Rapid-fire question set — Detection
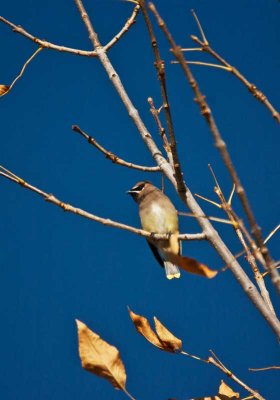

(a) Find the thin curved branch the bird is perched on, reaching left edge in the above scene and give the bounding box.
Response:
[0,165,206,240]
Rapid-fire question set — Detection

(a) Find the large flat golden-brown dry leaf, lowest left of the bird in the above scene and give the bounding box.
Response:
[76,320,126,390]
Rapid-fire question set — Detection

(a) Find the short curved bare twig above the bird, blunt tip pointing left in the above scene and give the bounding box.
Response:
[72,125,160,172]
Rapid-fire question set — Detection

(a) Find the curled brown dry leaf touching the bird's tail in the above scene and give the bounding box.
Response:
[168,254,218,279]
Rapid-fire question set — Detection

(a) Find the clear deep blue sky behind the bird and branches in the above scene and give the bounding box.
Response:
[0,0,280,400]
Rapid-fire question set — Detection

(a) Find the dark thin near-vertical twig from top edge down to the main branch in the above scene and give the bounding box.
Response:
[138,0,186,193]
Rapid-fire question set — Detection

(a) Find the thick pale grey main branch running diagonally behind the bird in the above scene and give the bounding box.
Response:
[70,0,280,338]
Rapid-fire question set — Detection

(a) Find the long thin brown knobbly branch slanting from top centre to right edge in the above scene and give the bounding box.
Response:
[150,3,280,294]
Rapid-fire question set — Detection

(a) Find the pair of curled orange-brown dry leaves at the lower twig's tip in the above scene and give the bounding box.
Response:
[128,309,182,353]
